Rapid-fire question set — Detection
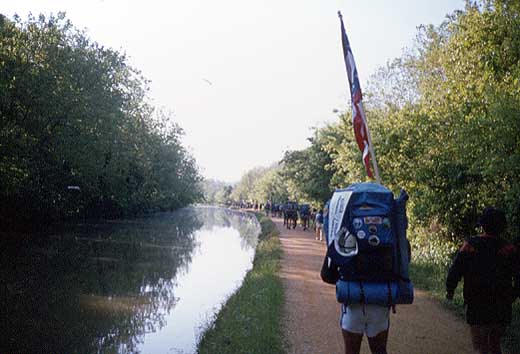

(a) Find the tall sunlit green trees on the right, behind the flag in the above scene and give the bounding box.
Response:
[323,1,520,239]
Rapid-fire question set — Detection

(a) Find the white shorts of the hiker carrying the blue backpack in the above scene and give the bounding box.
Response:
[340,304,390,338]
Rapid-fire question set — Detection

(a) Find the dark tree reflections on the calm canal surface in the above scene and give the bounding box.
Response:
[0,207,260,353]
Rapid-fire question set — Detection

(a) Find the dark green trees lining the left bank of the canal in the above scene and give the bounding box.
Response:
[0,14,201,227]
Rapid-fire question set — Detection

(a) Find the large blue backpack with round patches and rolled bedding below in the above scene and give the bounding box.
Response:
[323,183,413,306]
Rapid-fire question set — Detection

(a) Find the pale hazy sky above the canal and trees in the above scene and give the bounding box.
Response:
[6,0,464,181]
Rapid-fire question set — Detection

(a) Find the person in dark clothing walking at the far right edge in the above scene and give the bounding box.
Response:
[446,207,520,354]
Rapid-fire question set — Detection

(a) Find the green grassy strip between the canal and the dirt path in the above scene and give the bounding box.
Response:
[198,214,284,354]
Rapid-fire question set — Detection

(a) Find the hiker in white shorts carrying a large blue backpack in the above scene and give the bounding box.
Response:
[321,183,413,354]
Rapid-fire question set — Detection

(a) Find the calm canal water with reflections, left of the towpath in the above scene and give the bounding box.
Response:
[0,207,260,354]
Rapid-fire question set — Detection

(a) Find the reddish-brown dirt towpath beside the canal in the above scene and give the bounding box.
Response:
[273,218,472,354]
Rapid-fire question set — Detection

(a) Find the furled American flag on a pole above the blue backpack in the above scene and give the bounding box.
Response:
[338,11,374,178]
